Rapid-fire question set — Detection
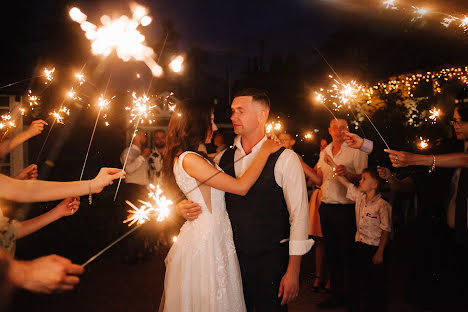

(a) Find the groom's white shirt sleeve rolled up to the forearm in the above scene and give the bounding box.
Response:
[275,150,314,256]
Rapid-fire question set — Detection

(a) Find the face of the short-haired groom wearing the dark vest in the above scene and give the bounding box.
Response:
[231,96,268,135]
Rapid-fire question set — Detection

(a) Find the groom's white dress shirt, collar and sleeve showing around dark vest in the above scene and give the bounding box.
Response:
[214,136,314,256]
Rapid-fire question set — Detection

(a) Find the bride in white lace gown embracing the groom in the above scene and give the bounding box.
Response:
[159,104,280,312]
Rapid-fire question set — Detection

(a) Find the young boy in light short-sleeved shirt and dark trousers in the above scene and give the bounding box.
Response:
[337,168,392,311]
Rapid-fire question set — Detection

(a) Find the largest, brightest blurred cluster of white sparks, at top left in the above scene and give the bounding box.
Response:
[69,3,163,77]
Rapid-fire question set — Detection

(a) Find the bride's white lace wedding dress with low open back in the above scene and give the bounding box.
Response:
[160,152,246,312]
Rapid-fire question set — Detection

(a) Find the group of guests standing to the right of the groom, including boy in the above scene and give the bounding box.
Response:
[279,103,468,311]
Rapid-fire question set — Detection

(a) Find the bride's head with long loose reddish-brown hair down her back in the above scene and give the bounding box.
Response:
[163,101,213,200]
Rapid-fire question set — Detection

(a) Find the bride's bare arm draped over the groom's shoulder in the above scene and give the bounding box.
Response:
[182,141,280,195]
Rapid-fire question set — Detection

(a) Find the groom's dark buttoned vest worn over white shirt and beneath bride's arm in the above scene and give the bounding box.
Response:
[219,147,289,253]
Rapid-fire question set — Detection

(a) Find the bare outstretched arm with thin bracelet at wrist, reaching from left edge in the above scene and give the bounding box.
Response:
[0,168,123,203]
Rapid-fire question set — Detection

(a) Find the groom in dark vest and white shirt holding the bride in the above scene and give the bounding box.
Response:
[179,89,313,312]
